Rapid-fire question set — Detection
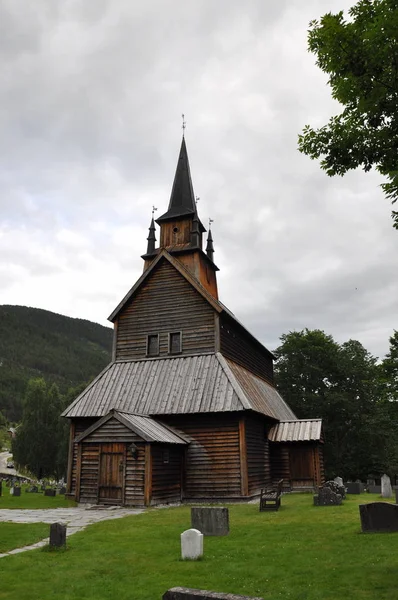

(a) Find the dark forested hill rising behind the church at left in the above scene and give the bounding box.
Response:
[0,305,112,421]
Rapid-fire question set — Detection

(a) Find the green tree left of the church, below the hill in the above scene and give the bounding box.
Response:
[12,379,63,478]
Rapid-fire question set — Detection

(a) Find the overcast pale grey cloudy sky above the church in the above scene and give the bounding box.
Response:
[0,0,398,357]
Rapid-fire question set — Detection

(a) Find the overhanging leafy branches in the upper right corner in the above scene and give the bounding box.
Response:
[299,0,398,229]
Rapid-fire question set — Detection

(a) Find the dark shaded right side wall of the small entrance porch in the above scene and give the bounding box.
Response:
[152,444,183,504]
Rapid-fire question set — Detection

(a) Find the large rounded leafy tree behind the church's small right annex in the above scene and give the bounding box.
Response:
[275,329,392,478]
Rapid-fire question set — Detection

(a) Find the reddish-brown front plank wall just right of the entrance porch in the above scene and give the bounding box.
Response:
[164,413,241,500]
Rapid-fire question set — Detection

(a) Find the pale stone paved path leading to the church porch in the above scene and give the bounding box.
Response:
[0,507,143,558]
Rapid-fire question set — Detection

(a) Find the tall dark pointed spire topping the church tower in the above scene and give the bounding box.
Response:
[156,137,199,227]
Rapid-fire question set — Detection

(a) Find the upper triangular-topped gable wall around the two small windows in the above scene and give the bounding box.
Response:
[116,261,214,360]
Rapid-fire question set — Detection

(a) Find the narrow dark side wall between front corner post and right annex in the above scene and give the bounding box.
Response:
[246,415,271,496]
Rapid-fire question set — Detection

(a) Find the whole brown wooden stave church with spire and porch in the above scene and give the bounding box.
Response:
[63,137,324,506]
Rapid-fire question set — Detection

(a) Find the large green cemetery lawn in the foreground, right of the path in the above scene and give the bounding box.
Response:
[0,494,398,600]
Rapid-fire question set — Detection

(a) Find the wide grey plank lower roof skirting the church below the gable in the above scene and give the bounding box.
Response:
[63,353,296,421]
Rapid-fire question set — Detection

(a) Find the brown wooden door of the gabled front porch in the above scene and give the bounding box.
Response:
[98,444,126,504]
